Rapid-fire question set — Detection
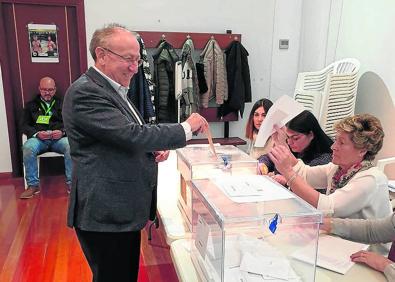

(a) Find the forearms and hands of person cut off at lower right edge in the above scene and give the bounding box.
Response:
[321,214,395,281]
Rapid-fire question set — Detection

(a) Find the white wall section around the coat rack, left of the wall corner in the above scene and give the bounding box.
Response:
[85,0,278,141]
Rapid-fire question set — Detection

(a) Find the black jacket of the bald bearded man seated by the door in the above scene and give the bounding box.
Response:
[21,95,65,138]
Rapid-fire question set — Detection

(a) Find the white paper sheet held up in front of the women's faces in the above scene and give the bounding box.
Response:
[255,95,305,147]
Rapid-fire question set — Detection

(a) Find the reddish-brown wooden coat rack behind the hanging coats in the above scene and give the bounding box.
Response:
[136,31,246,145]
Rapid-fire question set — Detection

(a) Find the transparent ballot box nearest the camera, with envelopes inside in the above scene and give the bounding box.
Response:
[191,175,322,282]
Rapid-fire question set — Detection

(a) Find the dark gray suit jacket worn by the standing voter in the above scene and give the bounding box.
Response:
[63,68,186,232]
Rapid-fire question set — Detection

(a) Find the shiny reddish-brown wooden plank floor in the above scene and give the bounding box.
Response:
[0,176,178,282]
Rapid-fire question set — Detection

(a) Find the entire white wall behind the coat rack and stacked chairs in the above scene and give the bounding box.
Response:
[0,0,395,175]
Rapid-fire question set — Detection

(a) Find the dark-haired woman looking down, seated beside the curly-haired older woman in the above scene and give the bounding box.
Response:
[258,110,333,178]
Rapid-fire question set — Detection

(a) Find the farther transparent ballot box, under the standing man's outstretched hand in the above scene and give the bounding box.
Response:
[176,145,258,230]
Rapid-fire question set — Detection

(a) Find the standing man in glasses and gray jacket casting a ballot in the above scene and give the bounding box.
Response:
[63,24,208,282]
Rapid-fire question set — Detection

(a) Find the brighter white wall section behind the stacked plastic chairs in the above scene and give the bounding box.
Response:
[299,0,395,177]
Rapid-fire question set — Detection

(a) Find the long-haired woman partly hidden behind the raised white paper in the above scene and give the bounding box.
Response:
[245,98,273,159]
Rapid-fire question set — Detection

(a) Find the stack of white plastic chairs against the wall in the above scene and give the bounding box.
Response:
[294,58,360,138]
